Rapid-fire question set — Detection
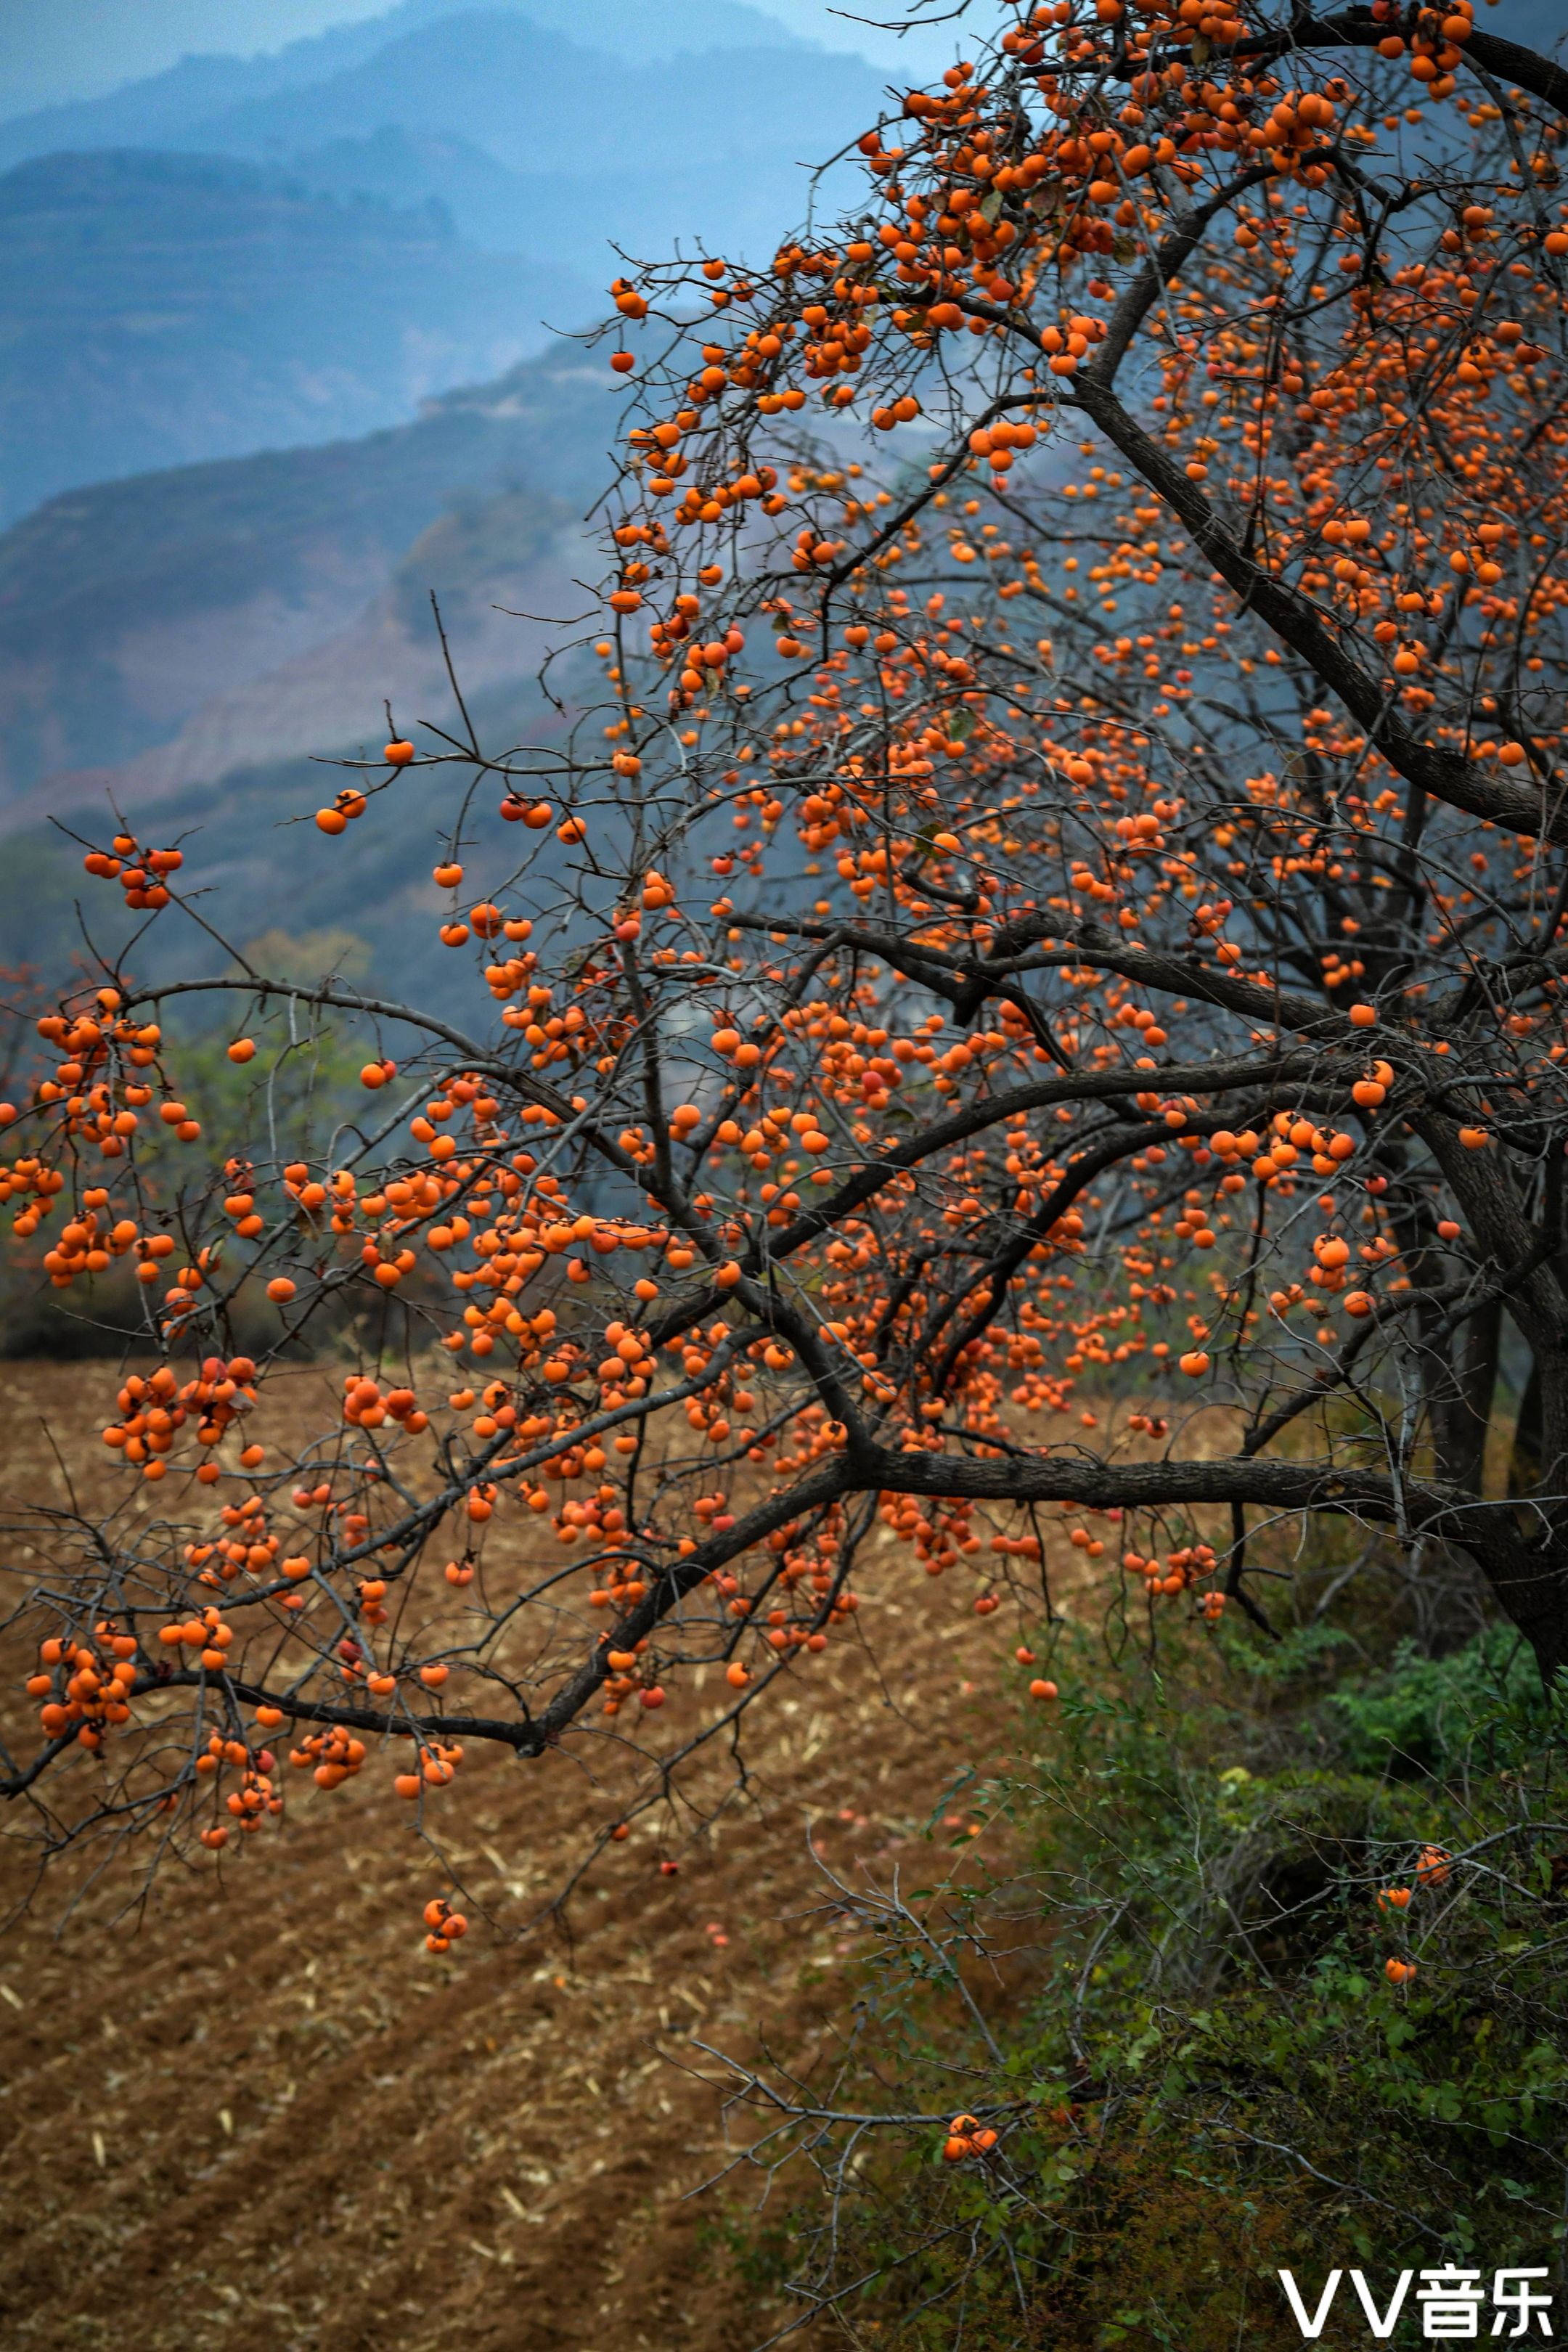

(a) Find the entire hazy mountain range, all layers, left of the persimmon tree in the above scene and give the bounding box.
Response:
[0,0,881,964]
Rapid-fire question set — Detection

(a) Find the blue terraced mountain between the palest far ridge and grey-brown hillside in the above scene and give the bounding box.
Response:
[0,153,595,520]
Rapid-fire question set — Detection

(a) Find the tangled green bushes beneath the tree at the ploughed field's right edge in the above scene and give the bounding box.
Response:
[719,1630,1568,2352]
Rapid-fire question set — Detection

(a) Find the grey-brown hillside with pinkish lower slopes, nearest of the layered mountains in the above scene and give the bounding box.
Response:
[0,343,623,804]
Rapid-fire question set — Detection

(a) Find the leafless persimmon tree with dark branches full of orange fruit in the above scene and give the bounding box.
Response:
[4,0,1568,1945]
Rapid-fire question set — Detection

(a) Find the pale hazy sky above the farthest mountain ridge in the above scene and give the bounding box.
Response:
[0,0,950,118]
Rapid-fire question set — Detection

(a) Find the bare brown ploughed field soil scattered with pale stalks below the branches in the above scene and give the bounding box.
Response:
[0,1364,1043,2352]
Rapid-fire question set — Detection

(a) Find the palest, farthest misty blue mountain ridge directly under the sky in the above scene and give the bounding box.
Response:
[0,0,881,277]
